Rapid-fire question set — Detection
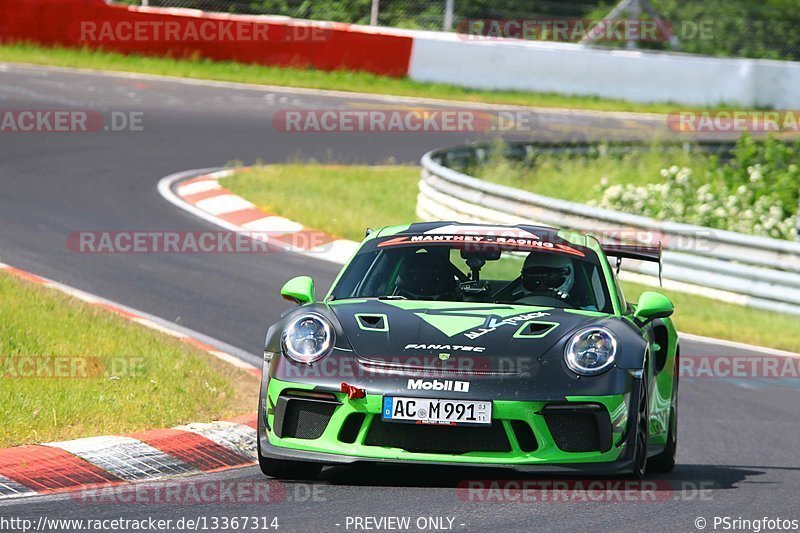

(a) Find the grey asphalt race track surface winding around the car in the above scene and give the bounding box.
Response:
[0,65,800,531]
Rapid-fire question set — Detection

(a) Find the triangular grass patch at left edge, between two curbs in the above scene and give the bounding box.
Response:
[0,273,258,447]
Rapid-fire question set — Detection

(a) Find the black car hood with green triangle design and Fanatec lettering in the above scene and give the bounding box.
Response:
[330,300,606,370]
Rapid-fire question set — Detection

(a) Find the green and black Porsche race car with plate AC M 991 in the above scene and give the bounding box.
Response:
[258,222,679,478]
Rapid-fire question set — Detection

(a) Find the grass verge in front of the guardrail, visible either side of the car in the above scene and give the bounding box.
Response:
[223,164,800,352]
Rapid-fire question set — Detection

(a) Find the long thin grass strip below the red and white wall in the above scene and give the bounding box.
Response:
[0,44,680,113]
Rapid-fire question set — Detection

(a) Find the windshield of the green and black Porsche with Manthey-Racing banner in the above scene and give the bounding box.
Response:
[331,239,612,313]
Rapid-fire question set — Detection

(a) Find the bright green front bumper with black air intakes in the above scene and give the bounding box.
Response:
[258,378,636,473]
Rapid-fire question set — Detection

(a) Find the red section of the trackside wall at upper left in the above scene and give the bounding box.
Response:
[0,0,412,77]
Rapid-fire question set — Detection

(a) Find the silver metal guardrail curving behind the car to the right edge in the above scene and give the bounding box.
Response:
[417,144,800,315]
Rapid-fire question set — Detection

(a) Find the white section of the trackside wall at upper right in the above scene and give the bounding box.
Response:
[408,32,800,109]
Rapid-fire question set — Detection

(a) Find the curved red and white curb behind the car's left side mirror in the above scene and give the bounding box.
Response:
[158,169,358,265]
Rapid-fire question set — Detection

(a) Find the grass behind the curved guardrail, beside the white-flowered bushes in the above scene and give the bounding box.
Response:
[467,145,708,203]
